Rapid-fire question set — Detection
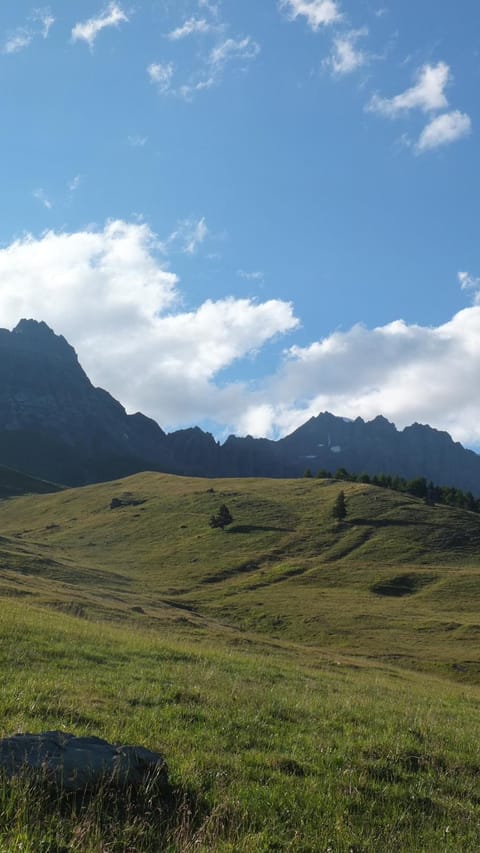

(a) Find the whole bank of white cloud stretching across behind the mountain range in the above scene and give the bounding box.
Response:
[4,221,480,443]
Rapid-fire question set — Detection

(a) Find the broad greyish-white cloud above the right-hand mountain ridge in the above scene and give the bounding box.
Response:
[240,305,480,444]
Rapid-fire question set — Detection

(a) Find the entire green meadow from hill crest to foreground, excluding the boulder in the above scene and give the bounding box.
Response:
[0,473,480,853]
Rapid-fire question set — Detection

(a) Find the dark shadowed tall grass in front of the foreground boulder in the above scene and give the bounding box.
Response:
[0,773,219,853]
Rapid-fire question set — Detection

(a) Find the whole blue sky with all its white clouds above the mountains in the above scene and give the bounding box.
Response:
[0,0,480,449]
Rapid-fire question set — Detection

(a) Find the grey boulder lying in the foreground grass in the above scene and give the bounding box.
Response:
[0,732,168,793]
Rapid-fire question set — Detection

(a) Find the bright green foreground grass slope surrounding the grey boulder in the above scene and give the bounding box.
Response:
[0,603,480,851]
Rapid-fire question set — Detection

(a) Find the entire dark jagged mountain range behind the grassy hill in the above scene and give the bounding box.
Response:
[0,320,480,495]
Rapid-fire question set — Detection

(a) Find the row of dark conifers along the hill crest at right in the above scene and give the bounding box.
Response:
[304,468,480,513]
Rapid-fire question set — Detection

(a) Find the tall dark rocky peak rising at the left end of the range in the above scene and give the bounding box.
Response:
[0,320,174,485]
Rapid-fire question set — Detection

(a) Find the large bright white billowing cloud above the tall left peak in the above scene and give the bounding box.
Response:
[0,221,298,426]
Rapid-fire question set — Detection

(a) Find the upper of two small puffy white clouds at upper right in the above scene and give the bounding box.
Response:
[368,62,451,118]
